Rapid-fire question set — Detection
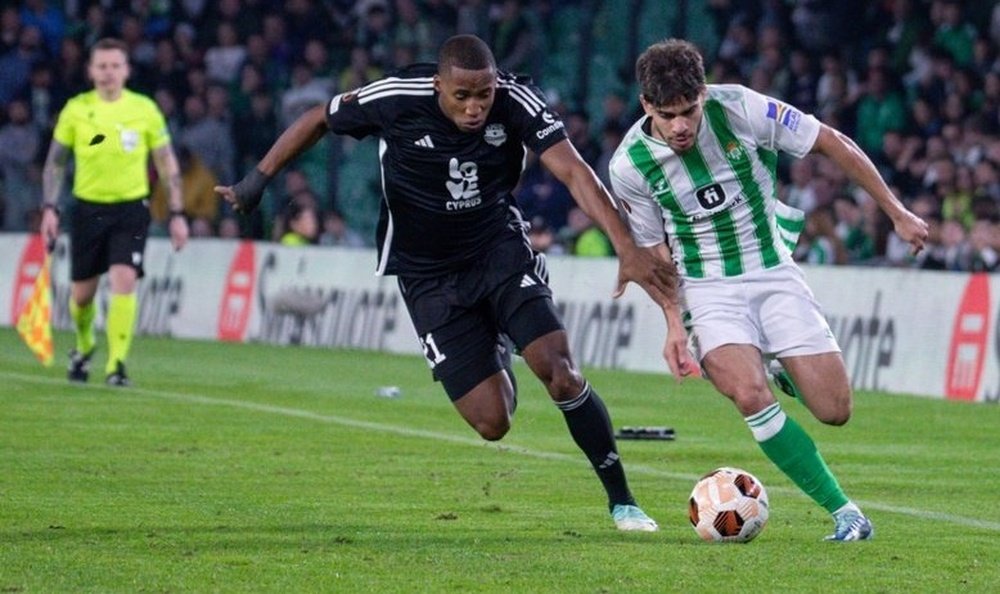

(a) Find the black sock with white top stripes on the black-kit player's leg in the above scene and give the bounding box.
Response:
[556,383,635,507]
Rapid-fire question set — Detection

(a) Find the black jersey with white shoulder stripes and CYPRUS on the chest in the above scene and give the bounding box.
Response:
[326,64,566,277]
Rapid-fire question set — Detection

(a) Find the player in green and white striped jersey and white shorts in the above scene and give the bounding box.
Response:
[610,39,927,541]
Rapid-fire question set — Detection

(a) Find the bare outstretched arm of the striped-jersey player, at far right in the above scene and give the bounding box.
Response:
[811,124,927,254]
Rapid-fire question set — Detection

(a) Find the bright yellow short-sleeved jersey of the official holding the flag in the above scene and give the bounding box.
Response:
[53,89,170,204]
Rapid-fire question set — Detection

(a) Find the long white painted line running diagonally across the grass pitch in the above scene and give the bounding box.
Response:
[7,372,1000,532]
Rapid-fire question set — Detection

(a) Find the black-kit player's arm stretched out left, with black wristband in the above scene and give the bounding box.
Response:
[215,104,328,212]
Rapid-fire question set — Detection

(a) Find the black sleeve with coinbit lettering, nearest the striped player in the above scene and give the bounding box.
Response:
[499,76,566,155]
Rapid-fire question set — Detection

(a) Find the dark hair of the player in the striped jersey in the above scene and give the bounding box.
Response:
[635,39,705,106]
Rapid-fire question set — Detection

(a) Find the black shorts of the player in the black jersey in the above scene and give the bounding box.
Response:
[398,238,564,400]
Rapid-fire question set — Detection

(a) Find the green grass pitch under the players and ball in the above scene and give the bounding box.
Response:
[0,329,1000,593]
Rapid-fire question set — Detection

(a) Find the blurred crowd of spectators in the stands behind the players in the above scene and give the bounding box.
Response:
[0,0,1000,271]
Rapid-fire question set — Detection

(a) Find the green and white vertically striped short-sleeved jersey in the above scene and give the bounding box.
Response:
[609,85,820,278]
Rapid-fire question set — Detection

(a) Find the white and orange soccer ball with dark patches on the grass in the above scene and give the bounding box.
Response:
[688,467,768,542]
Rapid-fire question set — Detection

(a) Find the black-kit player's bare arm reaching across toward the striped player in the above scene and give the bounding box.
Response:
[540,140,677,308]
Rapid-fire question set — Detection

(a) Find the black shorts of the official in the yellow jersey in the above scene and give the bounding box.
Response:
[69,199,150,281]
